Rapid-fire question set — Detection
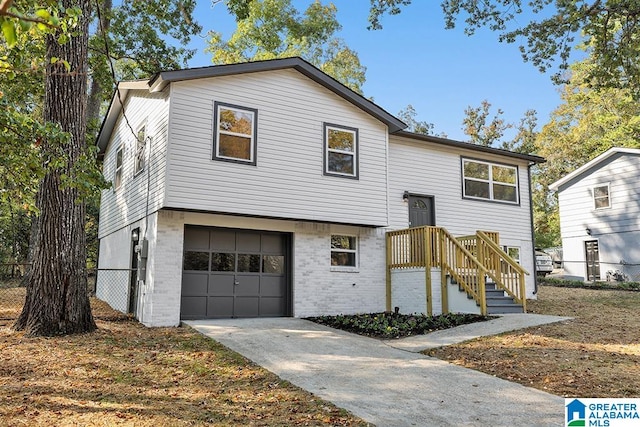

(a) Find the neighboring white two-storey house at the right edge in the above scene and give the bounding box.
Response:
[550,147,640,280]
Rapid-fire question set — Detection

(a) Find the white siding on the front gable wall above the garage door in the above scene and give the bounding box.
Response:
[166,69,388,226]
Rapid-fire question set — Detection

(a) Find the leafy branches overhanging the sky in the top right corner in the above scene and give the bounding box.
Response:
[369,0,640,98]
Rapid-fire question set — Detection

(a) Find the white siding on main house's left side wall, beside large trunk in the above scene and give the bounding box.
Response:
[99,91,169,238]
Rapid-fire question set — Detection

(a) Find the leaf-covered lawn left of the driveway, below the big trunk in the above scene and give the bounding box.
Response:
[0,294,368,427]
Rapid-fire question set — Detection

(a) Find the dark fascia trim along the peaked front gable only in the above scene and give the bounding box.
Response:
[149,57,407,133]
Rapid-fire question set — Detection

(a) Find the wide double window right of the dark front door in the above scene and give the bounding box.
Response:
[462,159,519,203]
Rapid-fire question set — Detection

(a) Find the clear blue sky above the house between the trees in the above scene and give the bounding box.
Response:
[189,0,560,140]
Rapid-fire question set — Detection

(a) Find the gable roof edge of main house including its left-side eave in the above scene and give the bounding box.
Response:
[97,57,407,153]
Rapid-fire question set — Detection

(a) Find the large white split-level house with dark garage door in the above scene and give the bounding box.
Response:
[97,58,543,326]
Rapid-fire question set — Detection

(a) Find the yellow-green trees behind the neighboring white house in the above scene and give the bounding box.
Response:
[533,60,640,246]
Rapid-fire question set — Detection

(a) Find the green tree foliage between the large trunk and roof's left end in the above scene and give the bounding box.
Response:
[87,0,202,130]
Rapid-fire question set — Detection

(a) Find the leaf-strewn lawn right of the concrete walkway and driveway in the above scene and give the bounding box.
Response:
[427,286,640,397]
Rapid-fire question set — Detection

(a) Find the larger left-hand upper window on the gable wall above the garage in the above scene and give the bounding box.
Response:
[213,102,258,165]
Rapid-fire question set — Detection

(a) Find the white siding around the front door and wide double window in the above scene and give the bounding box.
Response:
[389,135,535,296]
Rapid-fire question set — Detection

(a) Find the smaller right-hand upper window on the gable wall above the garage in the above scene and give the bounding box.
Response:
[324,123,358,178]
